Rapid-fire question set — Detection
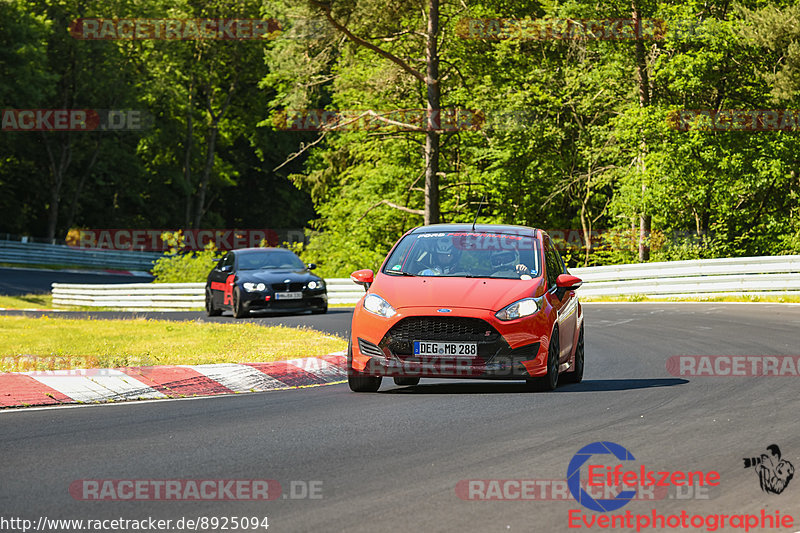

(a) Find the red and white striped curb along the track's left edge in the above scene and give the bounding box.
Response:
[0,352,347,408]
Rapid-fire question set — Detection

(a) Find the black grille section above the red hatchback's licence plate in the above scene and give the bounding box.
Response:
[387,317,500,342]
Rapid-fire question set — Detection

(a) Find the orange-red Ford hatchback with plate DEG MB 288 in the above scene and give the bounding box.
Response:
[348,224,584,392]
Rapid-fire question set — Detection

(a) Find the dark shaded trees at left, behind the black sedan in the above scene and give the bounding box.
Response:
[0,0,314,239]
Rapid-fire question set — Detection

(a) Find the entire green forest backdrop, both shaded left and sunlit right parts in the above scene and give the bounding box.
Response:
[0,0,800,276]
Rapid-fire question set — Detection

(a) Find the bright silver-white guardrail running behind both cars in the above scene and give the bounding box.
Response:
[48,255,800,310]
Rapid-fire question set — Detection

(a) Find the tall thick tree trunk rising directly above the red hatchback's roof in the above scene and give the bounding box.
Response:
[425,0,442,224]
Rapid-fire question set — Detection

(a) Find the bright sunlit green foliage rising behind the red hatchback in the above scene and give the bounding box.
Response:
[267,0,800,275]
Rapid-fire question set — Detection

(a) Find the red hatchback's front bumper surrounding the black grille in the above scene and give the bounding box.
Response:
[350,304,552,379]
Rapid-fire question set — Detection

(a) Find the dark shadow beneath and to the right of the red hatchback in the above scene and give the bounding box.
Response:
[379,378,689,394]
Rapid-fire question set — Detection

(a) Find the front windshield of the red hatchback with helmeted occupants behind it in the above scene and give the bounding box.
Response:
[383,231,540,279]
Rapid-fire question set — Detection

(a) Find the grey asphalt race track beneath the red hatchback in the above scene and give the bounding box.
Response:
[0,304,800,532]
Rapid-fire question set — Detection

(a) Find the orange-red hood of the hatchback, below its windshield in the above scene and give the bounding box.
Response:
[370,274,544,311]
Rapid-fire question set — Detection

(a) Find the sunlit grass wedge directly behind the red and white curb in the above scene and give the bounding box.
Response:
[0,316,347,372]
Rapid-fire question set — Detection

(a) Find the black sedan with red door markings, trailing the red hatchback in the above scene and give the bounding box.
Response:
[206,248,328,318]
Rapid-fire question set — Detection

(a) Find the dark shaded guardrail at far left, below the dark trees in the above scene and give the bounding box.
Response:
[0,241,163,271]
